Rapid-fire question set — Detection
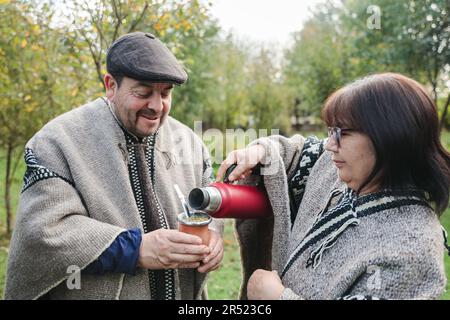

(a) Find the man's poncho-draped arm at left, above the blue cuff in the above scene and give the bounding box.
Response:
[5,168,124,299]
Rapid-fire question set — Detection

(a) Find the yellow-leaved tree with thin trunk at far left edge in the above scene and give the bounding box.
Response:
[0,1,87,233]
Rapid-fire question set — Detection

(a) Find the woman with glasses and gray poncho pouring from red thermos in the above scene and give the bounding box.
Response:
[218,73,450,299]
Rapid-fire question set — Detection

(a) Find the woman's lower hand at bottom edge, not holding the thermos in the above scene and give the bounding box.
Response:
[247,269,284,300]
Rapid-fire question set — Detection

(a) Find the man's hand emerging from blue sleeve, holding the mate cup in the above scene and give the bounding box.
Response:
[138,229,211,269]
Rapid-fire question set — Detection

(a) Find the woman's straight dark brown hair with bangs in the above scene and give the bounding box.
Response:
[322,73,450,214]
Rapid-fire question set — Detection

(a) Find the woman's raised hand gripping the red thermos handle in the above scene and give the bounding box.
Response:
[216,145,265,182]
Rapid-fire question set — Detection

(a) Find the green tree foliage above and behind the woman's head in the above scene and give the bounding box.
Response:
[284,0,450,123]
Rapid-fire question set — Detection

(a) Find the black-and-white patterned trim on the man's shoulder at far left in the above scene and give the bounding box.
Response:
[20,148,74,193]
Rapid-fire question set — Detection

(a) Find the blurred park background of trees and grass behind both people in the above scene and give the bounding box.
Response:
[0,0,450,299]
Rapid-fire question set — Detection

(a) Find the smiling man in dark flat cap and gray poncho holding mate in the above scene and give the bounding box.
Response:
[5,32,223,299]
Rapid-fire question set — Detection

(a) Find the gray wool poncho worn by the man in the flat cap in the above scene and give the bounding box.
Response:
[5,99,222,299]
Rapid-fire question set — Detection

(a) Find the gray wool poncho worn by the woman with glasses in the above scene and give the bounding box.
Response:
[236,135,446,299]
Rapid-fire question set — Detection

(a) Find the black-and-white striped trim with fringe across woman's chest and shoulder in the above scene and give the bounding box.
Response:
[281,189,430,278]
